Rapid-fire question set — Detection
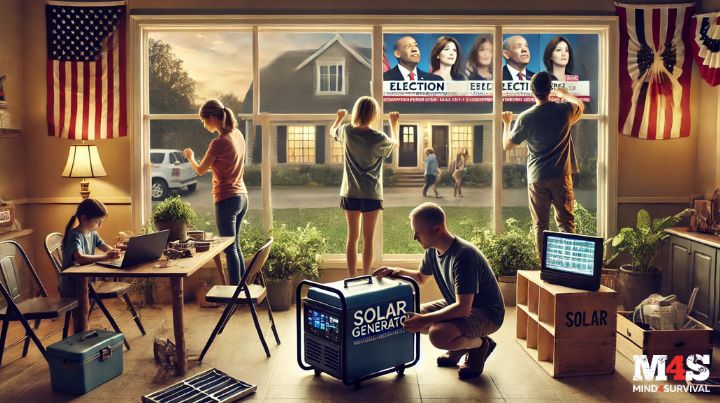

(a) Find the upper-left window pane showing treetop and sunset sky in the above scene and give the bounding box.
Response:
[148,31,253,113]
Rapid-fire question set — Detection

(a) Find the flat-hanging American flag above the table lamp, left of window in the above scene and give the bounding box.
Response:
[45,1,127,140]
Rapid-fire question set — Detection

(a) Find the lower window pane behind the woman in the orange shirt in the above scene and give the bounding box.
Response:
[147,119,263,240]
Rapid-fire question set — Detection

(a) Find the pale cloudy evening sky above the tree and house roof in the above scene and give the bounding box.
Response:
[150,31,371,104]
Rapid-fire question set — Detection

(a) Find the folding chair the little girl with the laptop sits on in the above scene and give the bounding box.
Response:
[45,232,145,350]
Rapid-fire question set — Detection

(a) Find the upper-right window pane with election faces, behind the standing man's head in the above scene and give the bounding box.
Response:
[503,34,599,113]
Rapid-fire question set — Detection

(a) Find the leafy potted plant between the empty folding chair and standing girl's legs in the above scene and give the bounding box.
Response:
[264,224,326,311]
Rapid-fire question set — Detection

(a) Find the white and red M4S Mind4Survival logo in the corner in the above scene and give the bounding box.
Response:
[633,354,710,393]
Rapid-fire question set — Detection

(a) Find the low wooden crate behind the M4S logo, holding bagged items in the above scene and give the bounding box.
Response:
[617,311,713,363]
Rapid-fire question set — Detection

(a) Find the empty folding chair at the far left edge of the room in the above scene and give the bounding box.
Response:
[0,241,78,364]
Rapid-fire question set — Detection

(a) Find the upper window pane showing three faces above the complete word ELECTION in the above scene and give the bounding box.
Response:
[383,33,493,113]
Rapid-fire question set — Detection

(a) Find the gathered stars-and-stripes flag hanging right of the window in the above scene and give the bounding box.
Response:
[615,3,695,140]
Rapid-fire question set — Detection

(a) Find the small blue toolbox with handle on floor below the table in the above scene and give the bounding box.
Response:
[47,330,125,395]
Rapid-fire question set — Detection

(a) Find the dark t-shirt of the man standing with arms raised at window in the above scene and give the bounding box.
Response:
[510,102,582,183]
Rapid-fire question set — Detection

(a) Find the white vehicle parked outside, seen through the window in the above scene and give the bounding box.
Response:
[150,148,197,200]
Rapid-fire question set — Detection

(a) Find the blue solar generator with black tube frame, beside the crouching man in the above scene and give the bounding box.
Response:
[296,276,420,387]
